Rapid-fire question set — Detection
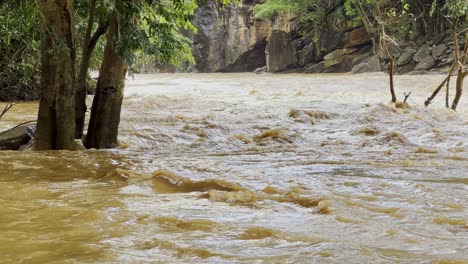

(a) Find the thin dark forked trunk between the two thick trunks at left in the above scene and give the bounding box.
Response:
[75,0,109,139]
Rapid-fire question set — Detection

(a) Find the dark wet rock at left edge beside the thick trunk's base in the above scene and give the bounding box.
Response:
[0,126,36,150]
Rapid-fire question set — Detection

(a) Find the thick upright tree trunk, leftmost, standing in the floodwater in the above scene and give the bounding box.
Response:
[36,0,75,149]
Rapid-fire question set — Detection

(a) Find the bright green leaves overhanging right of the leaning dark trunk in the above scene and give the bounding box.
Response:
[116,0,198,68]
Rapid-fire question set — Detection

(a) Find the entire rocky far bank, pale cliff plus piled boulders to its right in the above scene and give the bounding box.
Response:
[192,0,460,73]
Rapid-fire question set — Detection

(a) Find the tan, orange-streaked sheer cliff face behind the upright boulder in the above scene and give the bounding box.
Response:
[193,1,293,72]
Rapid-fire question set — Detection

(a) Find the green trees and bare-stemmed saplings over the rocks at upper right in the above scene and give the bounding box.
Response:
[254,0,468,105]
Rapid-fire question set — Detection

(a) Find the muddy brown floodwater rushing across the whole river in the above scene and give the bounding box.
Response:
[0,74,468,263]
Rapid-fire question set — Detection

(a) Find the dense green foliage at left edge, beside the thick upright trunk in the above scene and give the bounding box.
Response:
[0,1,40,101]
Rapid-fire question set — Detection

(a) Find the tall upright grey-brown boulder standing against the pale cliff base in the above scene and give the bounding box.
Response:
[265,30,296,72]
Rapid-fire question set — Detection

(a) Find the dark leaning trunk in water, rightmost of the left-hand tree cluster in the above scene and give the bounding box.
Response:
[84,7,128,149]
